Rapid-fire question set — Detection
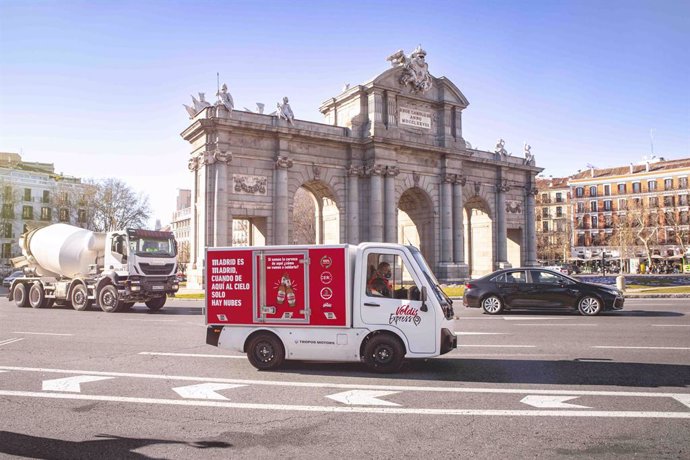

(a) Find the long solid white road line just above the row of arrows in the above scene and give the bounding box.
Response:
[0,366,690,398]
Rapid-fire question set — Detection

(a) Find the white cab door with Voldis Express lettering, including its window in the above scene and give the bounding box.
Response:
[356,248,432,353]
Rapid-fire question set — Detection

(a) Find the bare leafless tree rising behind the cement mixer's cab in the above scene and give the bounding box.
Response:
[84,178,151,232]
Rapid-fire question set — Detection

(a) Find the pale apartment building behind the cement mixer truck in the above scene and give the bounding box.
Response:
[0,152,89,273]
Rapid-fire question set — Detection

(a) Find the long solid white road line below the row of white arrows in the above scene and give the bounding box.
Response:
[0,390,690,420]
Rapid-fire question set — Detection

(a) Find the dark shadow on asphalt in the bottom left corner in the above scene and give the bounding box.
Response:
[0,431,233,460]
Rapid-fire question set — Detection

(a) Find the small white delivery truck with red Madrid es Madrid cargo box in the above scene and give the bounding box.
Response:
[205,243,457,372]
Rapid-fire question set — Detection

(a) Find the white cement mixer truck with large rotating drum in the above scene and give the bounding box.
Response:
[9,224,179,313]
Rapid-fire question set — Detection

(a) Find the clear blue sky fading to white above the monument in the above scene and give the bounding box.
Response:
[0,0,690,225]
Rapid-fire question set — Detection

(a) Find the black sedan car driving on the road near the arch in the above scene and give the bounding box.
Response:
[462,268,625,316]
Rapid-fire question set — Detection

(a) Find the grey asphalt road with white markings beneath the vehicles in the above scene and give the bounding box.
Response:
[0,298,690,459]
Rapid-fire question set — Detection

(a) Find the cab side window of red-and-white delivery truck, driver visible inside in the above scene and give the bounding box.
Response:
[366,253,420,300]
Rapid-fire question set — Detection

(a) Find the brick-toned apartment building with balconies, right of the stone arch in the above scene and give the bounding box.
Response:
[568,158,690,272]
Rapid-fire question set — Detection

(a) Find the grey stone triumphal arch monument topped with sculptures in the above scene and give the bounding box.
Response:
[182,47,541,285]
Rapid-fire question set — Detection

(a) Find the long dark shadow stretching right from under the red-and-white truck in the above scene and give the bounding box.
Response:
[281,357,690,388]
